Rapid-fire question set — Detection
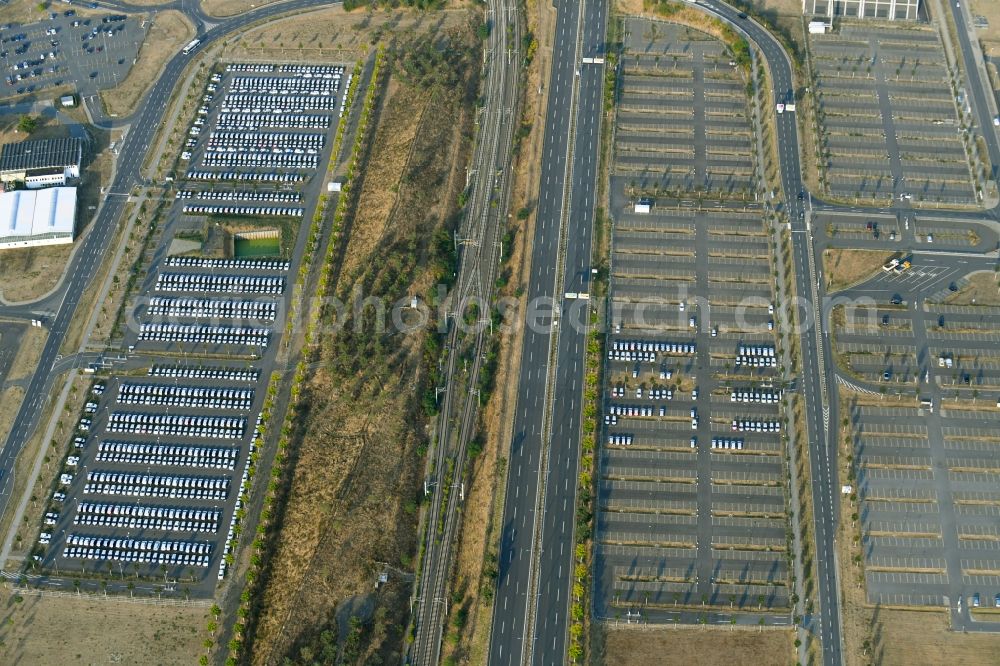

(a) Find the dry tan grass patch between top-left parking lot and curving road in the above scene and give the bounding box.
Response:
[101,9,195,116]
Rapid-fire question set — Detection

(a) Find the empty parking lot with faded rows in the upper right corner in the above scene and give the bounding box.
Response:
[809,20,976,203]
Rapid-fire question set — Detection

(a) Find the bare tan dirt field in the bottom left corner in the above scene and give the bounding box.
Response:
[0,585,208,666]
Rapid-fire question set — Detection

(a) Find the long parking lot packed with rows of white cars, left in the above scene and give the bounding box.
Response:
[38,64,352,594]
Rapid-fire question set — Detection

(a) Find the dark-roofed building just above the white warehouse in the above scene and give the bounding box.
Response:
[0,139,83,189]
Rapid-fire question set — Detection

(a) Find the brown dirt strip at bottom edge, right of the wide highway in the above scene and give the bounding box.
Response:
[595,627,795,666]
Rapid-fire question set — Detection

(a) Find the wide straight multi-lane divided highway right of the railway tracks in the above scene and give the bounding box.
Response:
[489,0,607,664]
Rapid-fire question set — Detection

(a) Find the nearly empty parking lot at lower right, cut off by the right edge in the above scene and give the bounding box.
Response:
[835,299,1000,607]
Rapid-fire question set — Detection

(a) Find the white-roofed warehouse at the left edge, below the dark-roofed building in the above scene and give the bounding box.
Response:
[0,187,76,250]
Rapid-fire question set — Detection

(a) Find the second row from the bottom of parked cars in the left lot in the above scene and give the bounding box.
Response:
[73,502,222,532]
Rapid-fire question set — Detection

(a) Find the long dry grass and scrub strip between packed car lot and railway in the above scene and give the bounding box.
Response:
[240,15,479,664]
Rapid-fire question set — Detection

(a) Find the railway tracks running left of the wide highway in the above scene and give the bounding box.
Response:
[410,0,521,666]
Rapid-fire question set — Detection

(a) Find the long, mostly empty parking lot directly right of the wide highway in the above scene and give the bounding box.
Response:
[596,19,789,621]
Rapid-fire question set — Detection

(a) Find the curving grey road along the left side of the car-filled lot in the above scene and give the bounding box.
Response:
[0,0,344,544]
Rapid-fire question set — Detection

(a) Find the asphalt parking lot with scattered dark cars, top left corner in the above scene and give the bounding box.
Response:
[0,11,148,96]
